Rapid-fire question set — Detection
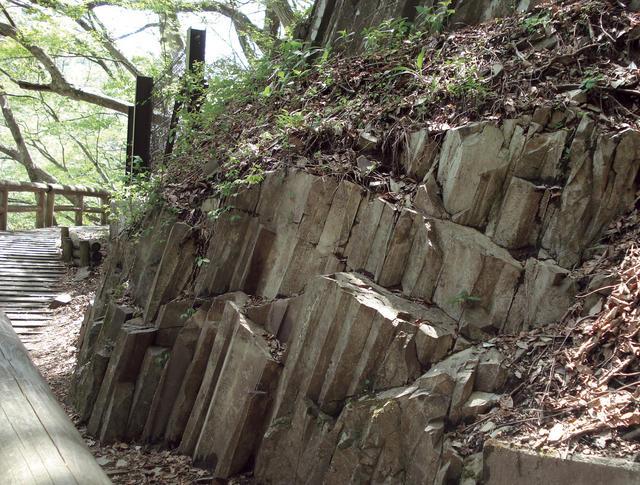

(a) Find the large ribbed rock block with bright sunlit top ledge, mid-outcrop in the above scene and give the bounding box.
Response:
[275,273,433,418]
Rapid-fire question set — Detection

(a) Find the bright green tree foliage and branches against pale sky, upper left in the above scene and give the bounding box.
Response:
[0,0,308,227]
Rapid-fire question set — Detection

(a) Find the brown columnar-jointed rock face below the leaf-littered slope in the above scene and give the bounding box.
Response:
[74,116,640,484]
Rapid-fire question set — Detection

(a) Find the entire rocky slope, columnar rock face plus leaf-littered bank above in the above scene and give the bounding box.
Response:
[75,1,640,484]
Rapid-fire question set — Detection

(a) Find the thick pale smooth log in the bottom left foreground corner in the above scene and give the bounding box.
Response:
[0,313,111,485]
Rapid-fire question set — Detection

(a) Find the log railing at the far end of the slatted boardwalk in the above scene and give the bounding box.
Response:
[0,180,111,231]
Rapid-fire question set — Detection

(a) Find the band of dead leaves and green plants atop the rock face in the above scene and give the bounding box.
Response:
[117,0,638,227]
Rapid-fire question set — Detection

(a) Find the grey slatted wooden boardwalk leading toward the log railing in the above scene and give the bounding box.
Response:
[0,227,66,347]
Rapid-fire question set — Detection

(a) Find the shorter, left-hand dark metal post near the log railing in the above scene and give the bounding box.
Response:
[132,76,153,174]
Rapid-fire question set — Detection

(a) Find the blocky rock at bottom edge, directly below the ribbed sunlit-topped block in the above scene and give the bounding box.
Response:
[322,387,448,484]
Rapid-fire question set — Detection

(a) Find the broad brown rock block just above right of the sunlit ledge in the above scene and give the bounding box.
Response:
[402,216,522,338]
